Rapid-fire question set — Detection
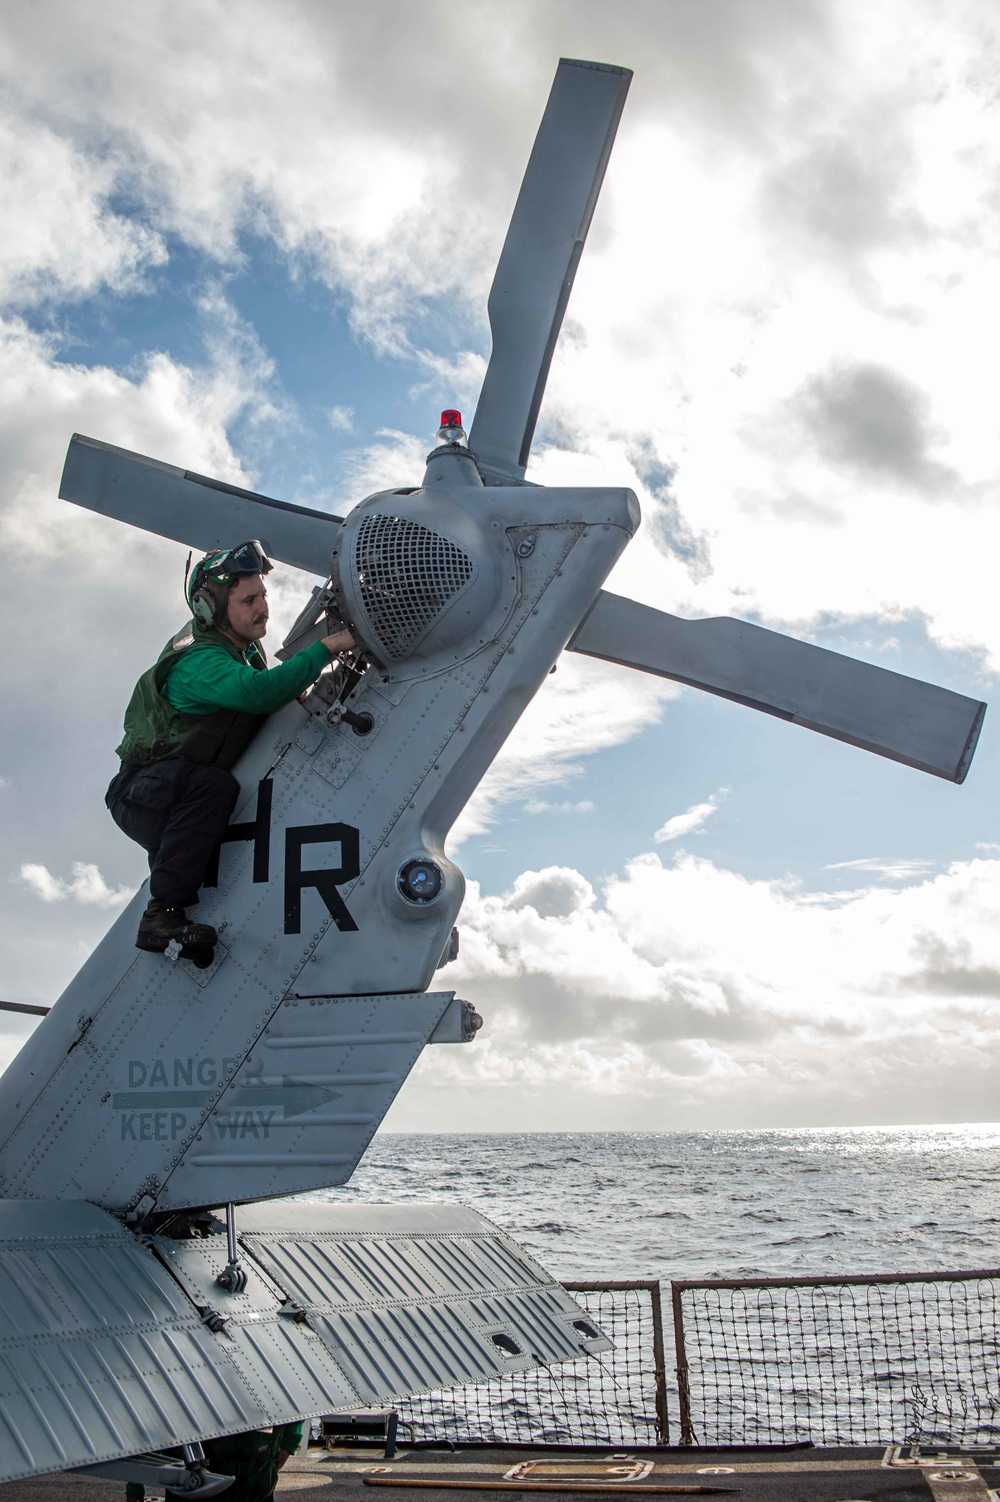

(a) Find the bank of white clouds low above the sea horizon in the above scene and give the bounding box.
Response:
[396,853,1000,1130]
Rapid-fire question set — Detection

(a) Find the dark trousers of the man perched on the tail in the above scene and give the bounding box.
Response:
[104,756,240,907]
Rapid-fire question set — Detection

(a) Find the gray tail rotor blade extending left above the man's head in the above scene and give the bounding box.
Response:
[59,433,341,578]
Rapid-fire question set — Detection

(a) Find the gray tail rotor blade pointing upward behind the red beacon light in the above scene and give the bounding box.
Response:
[468,57,632,484]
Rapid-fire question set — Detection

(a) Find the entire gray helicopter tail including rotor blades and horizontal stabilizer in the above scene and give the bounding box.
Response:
[0,60,983,1479]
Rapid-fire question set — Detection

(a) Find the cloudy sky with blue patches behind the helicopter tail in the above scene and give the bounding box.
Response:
[0,0,1000,1131]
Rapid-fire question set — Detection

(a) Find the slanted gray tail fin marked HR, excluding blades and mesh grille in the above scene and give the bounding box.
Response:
[0,487,638,1214]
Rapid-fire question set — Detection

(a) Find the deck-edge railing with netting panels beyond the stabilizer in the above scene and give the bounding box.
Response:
[398,1268,1000,1448]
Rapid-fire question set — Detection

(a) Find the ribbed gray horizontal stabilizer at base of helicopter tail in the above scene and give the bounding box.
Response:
[0,1200,610,1481]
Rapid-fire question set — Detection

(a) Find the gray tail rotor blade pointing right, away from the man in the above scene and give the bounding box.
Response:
[569,590,986,783]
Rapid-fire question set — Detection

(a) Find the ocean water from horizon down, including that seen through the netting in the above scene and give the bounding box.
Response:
[312,1125,1000,1445]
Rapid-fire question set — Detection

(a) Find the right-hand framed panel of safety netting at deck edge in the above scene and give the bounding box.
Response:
[673,1269,1000,1445]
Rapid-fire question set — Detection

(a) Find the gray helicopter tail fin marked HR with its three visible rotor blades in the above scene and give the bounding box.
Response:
[0,62,983,1223]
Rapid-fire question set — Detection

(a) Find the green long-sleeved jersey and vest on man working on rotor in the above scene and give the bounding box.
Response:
[117,620,330,771]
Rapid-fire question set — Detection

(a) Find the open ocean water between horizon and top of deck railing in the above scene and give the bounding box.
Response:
[320,1123,1000,1280]
